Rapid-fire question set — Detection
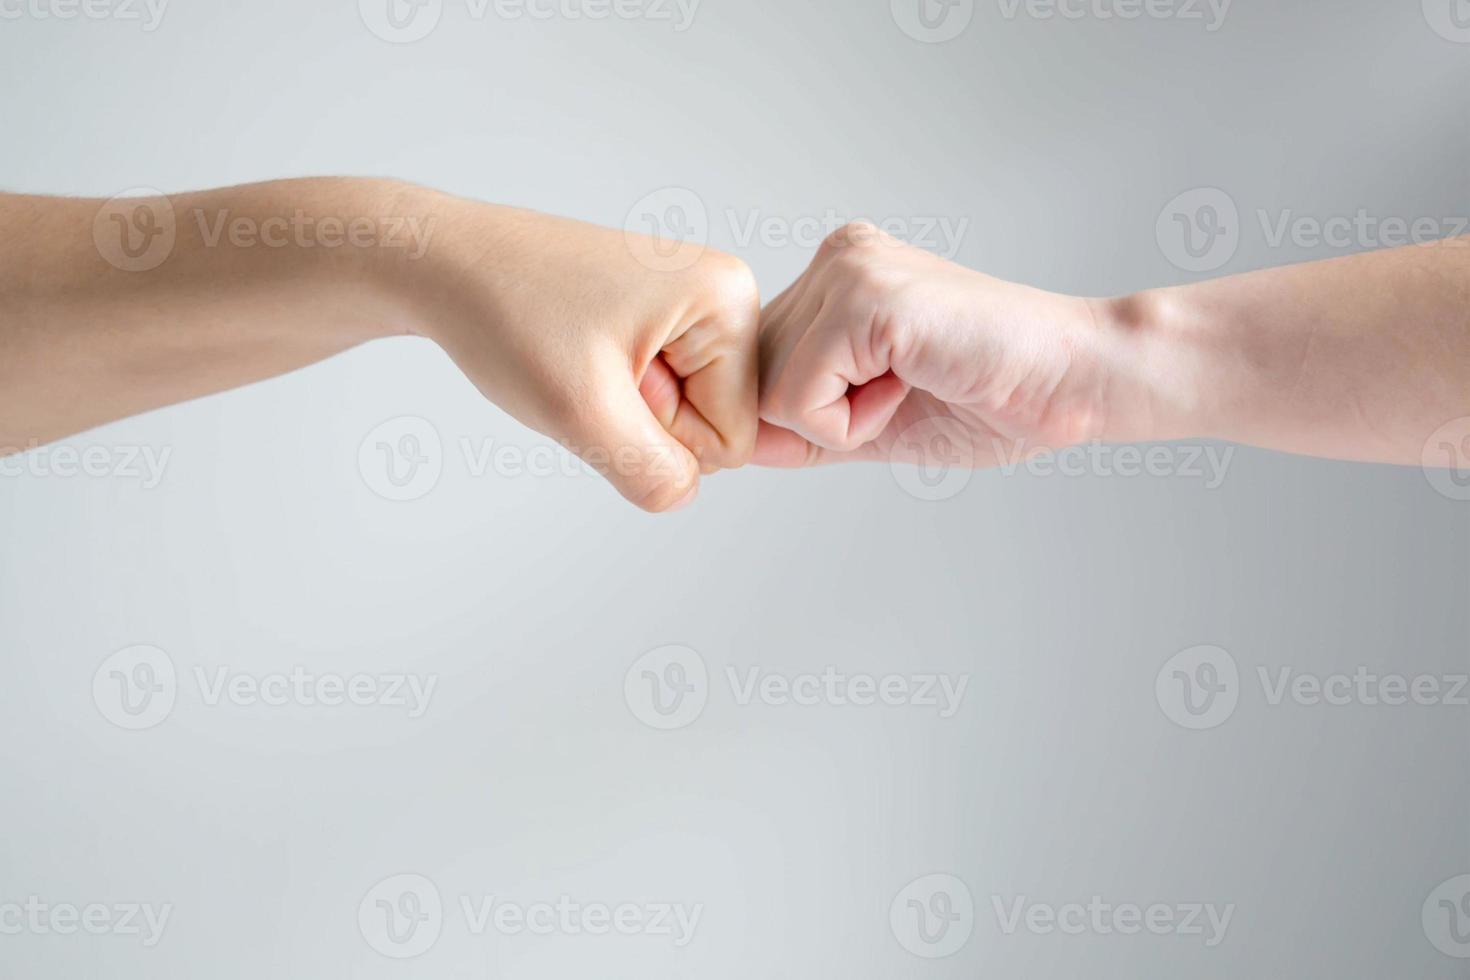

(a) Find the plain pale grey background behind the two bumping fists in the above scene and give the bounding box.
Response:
[0,0,1470,979]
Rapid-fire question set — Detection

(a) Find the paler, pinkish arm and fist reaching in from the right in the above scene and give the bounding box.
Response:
[756,225,1470,466]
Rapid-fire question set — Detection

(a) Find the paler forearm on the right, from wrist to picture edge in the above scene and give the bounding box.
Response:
[1094,238,1470,464]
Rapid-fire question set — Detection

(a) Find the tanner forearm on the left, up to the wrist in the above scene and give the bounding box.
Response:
[0,179,432,453]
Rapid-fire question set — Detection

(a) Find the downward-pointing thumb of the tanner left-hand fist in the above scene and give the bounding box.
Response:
[572,378,700,513]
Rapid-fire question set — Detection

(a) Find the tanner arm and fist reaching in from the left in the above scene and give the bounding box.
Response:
[0,179,760,511]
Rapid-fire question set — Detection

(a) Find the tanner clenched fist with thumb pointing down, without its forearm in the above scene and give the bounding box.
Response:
[404,195,760,511]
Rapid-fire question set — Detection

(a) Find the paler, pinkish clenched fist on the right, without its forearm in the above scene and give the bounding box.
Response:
[756,223,1103,466]
